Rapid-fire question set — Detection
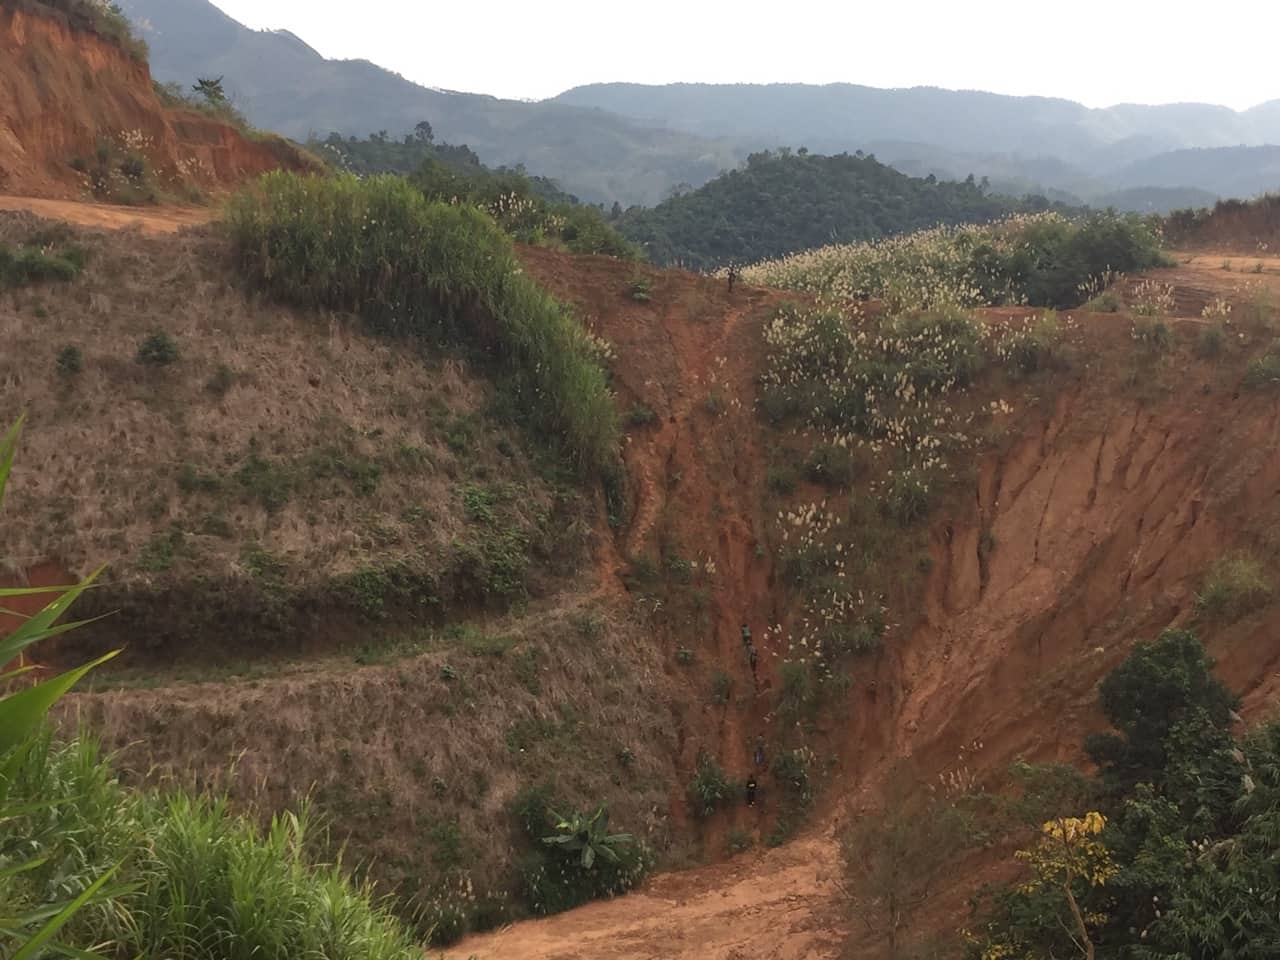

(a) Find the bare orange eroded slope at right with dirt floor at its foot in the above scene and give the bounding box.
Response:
[448,273,1280,960]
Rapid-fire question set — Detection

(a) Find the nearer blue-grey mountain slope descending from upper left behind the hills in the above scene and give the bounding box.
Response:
[122,0,746,205]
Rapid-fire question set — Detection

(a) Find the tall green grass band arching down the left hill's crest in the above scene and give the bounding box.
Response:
[229,172,620,471]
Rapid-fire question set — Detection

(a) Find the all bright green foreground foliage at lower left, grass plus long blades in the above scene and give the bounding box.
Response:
[0,421,419,960]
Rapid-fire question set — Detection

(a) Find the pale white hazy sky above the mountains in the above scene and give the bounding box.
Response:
[214,0,1280,109]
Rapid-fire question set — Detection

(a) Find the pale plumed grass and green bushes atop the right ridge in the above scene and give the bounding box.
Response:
[742,214,1164,311]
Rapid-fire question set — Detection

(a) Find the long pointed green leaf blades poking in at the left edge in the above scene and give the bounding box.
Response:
[0,417,123,960]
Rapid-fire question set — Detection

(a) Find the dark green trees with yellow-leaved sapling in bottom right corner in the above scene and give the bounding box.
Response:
[968,631,1280,960]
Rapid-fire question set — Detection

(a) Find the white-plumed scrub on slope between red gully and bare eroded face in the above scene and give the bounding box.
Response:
[759,305,1066,718]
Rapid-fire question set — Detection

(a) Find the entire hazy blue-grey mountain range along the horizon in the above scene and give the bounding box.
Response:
[122,0,1280,209]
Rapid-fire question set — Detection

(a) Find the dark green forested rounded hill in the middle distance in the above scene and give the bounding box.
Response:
[617,150,1050,270]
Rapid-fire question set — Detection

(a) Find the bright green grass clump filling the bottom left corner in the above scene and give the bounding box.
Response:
[0,732,421,960]
